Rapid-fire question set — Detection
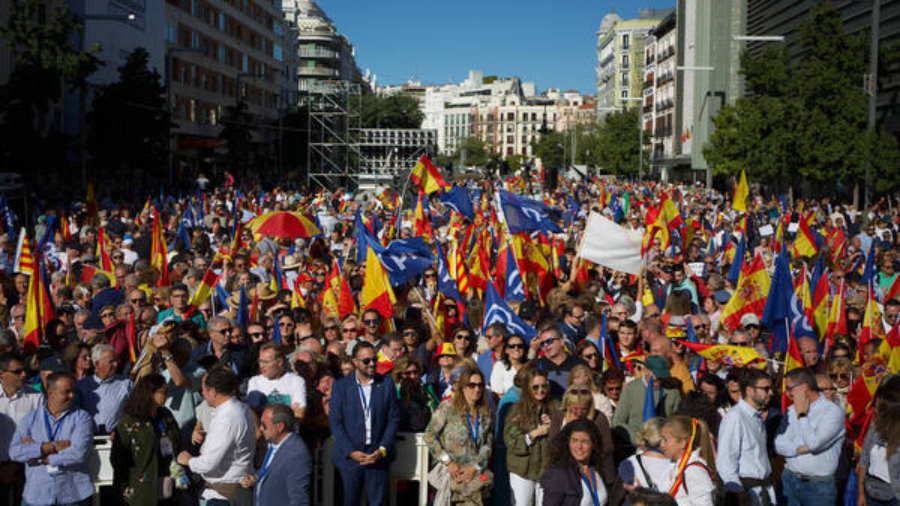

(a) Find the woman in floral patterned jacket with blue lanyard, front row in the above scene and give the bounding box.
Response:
[425,367,494,505]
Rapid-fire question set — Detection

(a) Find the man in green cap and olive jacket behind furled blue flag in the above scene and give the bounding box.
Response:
[612,355,681,438]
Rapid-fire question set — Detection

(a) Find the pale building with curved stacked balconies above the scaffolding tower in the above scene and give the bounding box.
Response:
[280,0,363,94]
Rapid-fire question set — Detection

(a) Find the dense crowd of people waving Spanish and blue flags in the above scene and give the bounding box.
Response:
[0,170,900,506]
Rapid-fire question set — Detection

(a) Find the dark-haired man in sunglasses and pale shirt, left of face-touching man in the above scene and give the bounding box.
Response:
[716,369,776,506]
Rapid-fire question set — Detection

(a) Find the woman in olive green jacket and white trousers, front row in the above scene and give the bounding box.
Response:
[503,369,551,506]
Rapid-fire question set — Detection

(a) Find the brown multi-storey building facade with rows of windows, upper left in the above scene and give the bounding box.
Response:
[165,0,290,165]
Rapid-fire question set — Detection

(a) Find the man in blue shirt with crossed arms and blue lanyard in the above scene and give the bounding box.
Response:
[9,372,94,506]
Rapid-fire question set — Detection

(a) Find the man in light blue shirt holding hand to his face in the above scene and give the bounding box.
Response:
[775,368,845,506]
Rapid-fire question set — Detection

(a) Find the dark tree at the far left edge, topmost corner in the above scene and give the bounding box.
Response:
[0,0,102,175]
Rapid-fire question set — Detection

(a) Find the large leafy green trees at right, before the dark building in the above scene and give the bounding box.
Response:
[703,2,900,199]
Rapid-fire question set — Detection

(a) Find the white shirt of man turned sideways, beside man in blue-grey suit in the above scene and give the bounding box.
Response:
[188,397,256,499]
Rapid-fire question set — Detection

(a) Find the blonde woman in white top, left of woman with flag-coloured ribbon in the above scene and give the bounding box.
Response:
[619,418,673,492]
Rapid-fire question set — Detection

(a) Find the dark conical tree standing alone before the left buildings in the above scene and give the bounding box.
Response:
[87,48,170,177]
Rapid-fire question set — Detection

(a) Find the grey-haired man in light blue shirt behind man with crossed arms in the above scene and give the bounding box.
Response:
[77,344,132,434]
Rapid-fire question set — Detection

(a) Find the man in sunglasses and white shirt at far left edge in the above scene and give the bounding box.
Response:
[0,353,43,504]
